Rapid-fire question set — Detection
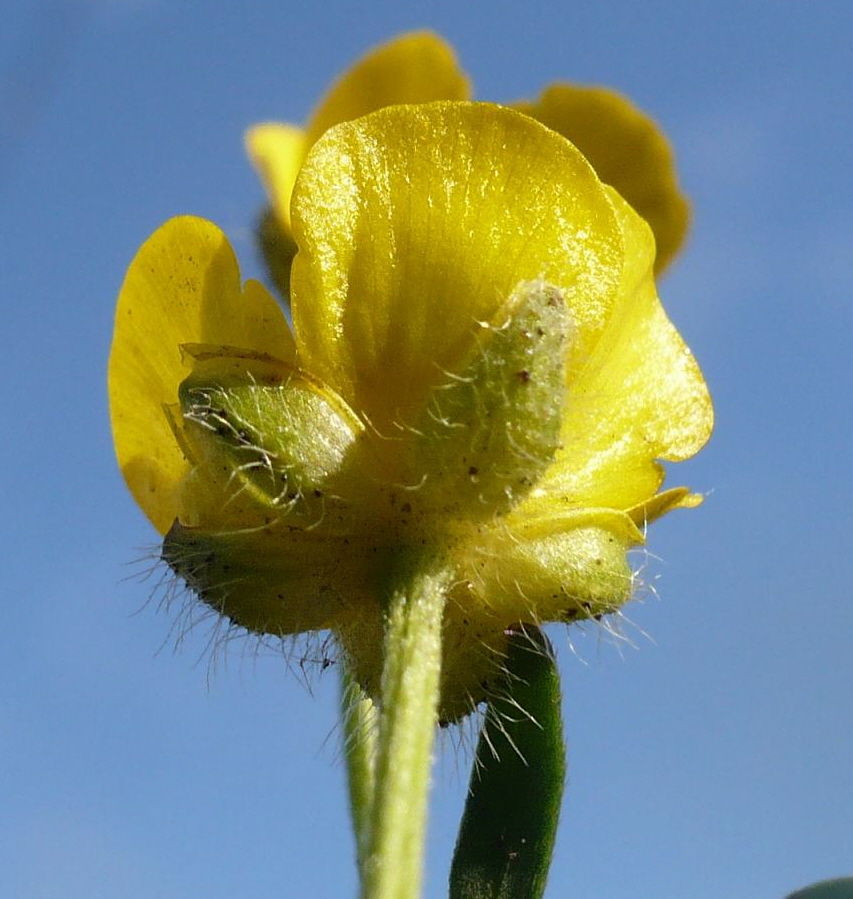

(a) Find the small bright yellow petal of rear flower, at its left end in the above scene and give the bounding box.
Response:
[245,122,308,233]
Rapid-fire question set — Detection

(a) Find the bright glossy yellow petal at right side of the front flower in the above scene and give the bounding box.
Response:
[531,192,713,514]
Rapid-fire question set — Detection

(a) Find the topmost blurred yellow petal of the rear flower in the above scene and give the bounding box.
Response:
[307,31,471,144]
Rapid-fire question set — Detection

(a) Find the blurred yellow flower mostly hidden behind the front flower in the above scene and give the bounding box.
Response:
[246,31,689,288]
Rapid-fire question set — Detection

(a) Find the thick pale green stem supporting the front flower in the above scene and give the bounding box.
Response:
[361,556,451,899]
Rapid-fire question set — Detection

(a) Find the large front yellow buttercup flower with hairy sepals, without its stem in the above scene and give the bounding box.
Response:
[109,102,712,721]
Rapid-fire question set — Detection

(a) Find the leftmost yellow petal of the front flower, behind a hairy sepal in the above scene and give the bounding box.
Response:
[109,216,295,534]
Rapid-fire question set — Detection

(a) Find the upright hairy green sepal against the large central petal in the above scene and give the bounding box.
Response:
[408,281,574,520]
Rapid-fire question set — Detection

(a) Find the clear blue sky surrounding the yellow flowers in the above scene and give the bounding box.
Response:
[0,0,853,899]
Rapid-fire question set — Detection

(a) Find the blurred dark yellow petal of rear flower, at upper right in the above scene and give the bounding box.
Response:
[515,84,690,272]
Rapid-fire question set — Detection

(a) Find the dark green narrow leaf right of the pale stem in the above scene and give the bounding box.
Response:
[450,626,566,899]
